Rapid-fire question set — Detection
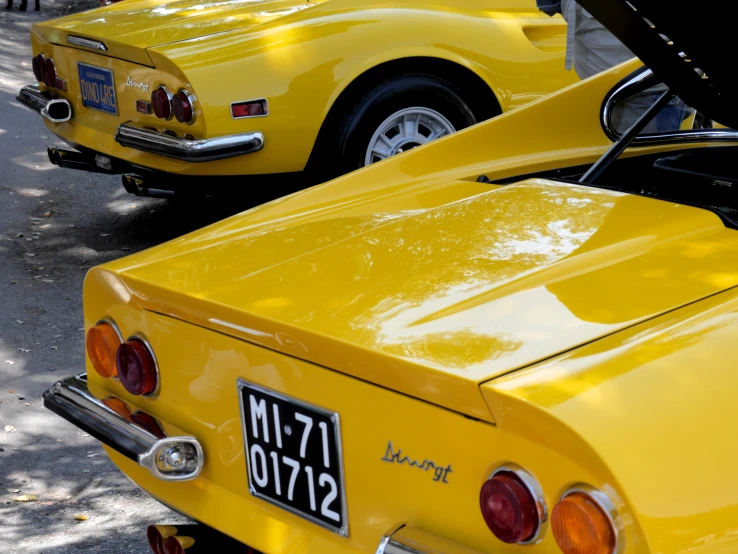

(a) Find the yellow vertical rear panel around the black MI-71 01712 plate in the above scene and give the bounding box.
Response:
[87,306,644,554]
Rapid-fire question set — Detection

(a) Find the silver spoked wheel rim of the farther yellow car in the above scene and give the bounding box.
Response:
[364,107,456,165]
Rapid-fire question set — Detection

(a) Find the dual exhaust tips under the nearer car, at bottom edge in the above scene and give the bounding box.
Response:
[146,524,262,554]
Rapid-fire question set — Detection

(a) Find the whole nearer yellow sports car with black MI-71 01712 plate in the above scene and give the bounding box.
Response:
[44,0,738,554]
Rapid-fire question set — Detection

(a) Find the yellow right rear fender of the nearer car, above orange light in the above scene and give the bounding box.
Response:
[482,286,738,554]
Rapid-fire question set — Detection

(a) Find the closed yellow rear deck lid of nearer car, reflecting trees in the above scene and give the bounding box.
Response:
[110,180,738,419]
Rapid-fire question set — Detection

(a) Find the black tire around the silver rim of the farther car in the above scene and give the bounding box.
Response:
[320,73,477,177]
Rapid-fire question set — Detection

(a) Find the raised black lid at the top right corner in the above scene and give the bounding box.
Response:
[578,0,738,128]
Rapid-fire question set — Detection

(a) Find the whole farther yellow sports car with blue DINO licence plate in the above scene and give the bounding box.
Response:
[18,0,576,194]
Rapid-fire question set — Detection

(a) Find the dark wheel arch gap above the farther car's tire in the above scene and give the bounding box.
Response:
[307,56,502,175]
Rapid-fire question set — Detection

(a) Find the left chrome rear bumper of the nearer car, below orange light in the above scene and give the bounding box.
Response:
[43,373,204,481]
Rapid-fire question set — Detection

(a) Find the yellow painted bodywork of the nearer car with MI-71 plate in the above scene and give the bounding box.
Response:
[73,58,738,554]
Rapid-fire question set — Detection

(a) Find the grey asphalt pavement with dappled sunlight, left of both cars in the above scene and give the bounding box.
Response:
[0,0,282,554]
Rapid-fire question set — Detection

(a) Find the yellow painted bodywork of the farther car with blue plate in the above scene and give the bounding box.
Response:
[32,0,576,175]
